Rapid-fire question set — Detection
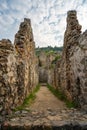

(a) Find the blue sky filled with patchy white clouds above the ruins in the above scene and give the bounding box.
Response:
[0,0,87,47]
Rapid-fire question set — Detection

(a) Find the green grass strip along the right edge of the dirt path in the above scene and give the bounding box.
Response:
[47,84,78,108]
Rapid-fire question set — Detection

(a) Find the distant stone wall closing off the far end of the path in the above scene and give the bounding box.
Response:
[39,51,56,84]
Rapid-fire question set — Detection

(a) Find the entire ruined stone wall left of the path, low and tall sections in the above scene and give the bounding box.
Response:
[0,19,38,114]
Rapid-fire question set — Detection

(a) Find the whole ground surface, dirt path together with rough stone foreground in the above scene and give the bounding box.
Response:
[1,86,87,130]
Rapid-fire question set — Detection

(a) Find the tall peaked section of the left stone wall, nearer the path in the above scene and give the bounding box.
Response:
[14,18,38,98]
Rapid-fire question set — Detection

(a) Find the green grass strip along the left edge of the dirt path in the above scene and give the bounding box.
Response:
[14,84,40,111]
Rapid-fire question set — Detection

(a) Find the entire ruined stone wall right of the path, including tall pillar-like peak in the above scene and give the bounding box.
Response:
[53,10,87,110]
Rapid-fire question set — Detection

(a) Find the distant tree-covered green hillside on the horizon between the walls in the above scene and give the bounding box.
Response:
[36,46,63,55]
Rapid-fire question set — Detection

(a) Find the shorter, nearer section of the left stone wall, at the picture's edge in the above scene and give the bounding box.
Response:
[0,39,17,114]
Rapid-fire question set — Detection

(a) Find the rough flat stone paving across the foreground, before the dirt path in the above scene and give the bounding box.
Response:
[1,109,87,130]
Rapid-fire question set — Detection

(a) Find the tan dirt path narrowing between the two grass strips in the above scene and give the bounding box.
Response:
[30,86,65,111]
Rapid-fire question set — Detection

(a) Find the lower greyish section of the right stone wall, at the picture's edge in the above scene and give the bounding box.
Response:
[69,31,87,109]
